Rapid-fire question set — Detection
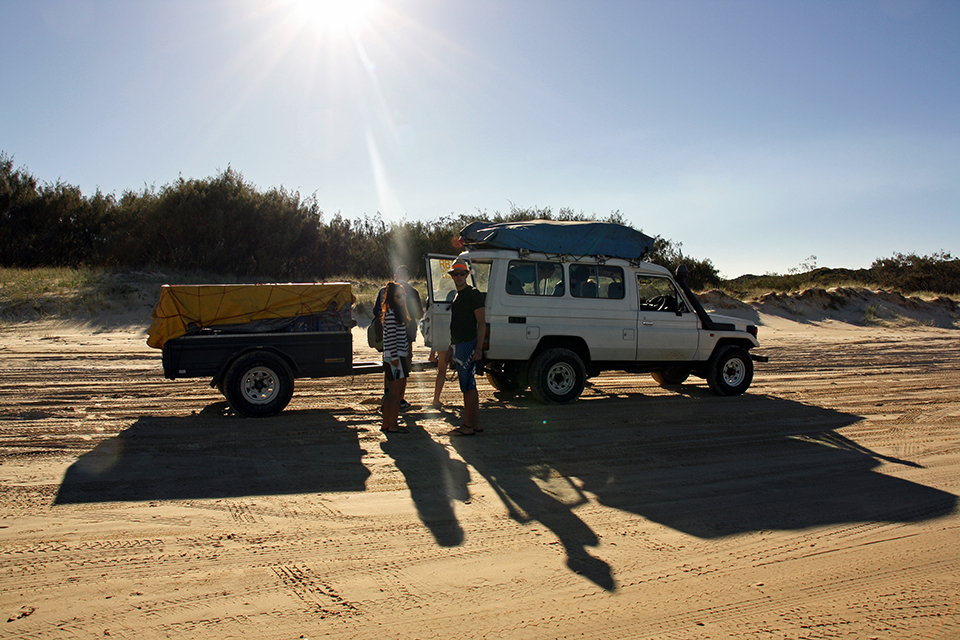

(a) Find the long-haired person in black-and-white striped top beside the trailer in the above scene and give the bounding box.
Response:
[380,282,410,433]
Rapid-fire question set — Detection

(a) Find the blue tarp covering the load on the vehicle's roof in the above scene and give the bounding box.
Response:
[460,220,653,260]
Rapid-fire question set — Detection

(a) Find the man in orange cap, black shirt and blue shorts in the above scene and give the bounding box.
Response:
[447,260,487,436]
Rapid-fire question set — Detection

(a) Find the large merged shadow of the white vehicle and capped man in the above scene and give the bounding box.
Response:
[453,393,957,590]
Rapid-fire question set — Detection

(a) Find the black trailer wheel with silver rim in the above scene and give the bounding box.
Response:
[223,351,293,418]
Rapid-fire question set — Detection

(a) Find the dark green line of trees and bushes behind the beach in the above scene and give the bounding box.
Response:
[0,152,960,294]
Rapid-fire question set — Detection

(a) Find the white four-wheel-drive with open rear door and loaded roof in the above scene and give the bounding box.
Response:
[423,221,767,403]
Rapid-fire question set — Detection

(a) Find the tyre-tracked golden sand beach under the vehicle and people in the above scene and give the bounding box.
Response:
[0,292,960,640]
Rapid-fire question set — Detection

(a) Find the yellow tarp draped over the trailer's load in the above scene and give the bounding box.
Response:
[147,282,357,349]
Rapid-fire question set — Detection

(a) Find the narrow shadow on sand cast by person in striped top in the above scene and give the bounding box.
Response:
[380,418,470,547]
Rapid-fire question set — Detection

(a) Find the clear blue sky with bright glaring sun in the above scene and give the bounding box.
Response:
[0,0,960,278]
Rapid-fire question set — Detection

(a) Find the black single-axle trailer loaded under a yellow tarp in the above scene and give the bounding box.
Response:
[147,282,402,417]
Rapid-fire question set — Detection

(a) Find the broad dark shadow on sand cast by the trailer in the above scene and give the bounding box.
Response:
[55,402,370,504]
